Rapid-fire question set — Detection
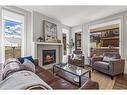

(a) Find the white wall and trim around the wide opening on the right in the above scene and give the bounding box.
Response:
[72,11,127,73]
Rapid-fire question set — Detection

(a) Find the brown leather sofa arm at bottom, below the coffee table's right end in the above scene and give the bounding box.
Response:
[80,80,99,90]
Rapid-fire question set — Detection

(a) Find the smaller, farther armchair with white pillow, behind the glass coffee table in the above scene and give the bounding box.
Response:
[68,50,84,67]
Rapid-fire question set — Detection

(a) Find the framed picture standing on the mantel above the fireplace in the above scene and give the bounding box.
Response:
[43,20,57,42]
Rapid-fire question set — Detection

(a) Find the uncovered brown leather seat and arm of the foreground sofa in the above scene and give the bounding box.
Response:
[35,59,99,89]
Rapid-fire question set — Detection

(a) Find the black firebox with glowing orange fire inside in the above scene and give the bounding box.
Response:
[42,49,56,65]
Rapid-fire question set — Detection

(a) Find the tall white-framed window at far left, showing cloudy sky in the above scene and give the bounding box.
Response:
[1,9,25,62]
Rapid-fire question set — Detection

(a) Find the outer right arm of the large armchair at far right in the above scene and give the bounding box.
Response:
[109,59,125,75]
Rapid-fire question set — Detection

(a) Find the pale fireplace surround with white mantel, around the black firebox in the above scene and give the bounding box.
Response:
[33,42,63,69]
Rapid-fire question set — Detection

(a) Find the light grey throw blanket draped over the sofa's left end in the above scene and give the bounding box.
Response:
[0,59,52,89]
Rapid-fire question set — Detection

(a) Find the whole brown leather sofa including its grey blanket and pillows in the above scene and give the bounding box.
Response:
[0,56,99,90]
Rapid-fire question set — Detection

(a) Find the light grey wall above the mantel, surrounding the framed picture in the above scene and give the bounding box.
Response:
[33,11,62,42]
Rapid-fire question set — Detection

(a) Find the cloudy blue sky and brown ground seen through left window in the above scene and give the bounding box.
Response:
[4,20,22,59]
